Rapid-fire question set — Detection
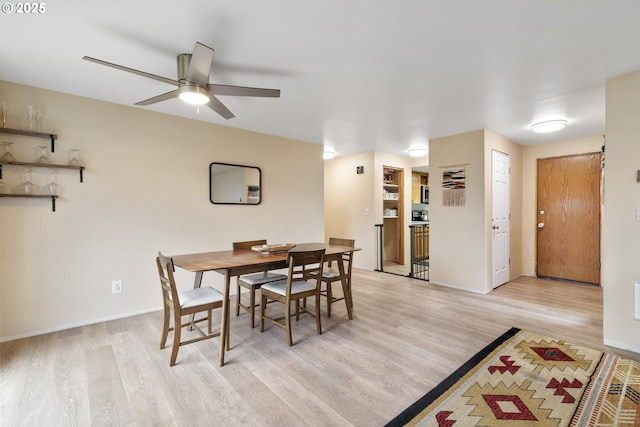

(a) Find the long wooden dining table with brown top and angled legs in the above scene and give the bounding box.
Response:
[171,243,360,366]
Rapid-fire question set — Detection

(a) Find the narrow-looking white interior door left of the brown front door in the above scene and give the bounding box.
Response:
[491,151,510,288]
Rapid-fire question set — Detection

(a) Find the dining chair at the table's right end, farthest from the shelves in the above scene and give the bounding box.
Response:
[320,237,356,320]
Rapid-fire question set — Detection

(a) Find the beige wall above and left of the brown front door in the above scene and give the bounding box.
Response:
[522,136,603,276]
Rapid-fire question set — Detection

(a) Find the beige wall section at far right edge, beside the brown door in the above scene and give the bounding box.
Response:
[602,72,640,352]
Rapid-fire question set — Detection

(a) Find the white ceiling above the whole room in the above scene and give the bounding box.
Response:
[0,0,640,155]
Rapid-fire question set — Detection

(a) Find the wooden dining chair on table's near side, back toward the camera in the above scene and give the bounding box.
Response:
[260,249,325,346]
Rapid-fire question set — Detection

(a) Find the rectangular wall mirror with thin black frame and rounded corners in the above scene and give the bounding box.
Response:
[209,162,262,205]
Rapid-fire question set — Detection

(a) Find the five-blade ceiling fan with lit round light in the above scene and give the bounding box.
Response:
[82,42,280,119]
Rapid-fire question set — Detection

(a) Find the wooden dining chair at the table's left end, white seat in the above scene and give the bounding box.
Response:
[156,252,223,366]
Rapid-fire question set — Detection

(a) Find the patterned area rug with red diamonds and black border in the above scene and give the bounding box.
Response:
[387,328,640,427]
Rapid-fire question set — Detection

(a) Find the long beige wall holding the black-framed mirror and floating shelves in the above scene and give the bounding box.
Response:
[0,81,324,340]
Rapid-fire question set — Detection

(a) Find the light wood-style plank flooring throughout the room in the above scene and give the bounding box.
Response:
[0,269,640,427]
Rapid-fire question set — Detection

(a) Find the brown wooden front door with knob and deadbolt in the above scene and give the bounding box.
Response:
[537,153,601,284]
